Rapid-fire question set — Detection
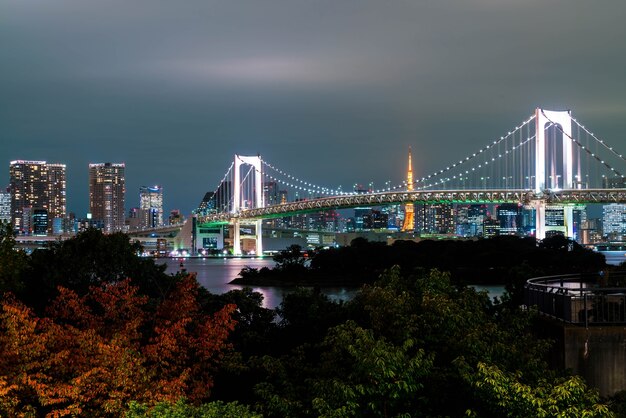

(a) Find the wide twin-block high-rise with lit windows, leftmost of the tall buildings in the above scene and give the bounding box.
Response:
[9,160,66,234]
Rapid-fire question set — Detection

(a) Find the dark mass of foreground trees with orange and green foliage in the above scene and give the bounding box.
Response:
[0,222,620,418]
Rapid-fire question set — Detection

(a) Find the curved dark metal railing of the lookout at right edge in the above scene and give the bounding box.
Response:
[524,271,626,326]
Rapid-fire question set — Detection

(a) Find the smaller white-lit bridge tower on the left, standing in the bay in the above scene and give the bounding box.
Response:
[231,154,264,255]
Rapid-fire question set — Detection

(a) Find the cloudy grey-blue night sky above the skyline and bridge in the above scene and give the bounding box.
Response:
[0,0,626,216]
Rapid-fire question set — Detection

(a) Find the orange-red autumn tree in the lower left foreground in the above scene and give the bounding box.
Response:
[0,276,235,416]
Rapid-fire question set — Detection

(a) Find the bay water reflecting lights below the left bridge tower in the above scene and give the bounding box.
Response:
[157,258,357,309]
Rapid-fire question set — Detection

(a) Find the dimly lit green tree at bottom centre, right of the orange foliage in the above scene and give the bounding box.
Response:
[312,321,433,417]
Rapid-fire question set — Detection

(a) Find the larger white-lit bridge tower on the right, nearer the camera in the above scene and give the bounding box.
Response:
[535,108,580,239]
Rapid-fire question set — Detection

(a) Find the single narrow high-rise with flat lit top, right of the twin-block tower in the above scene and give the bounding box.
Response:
[89,163,126,233]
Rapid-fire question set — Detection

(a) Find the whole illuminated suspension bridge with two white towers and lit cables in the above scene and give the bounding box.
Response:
[197,108,626,255]
